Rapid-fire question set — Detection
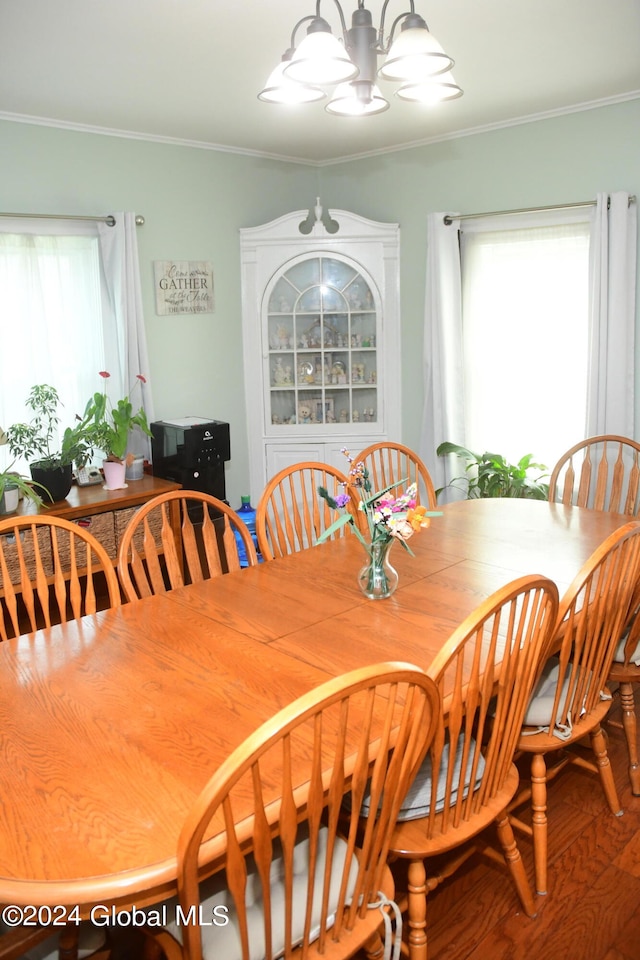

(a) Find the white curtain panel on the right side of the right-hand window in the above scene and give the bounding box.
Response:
[587,192,637,437]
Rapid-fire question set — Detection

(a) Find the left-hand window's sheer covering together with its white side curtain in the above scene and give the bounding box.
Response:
[0,214,153,473]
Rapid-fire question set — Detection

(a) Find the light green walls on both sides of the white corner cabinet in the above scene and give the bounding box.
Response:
[0,100,640,496]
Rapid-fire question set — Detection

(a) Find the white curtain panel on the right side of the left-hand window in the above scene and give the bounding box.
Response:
[98,213,154,459]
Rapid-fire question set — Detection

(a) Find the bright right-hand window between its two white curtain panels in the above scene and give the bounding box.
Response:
[461,218,590,467]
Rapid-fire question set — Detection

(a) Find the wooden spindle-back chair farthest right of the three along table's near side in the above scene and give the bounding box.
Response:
[512,520,640,894]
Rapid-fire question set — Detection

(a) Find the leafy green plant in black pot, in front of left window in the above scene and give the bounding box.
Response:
[6,383,91,502]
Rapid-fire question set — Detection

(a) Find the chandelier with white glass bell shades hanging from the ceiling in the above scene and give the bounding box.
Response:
[258,0,462,117]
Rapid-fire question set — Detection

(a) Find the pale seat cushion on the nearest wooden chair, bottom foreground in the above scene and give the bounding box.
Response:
[161,827,358,960]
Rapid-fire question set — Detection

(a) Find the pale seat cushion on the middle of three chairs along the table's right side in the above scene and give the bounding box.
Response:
[362,737,485,821]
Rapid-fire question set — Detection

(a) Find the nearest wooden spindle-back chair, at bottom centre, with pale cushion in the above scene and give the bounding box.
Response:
[140,663,439,960]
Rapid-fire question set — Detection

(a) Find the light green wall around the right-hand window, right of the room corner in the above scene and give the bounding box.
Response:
[322,100,640,448]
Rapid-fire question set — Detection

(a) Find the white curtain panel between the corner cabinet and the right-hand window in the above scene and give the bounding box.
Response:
[419,213,465,499]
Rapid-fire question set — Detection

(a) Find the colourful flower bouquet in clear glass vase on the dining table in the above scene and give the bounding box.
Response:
[318,447,442,600]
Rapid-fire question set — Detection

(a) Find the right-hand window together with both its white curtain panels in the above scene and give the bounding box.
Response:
[419,191,637,496]
